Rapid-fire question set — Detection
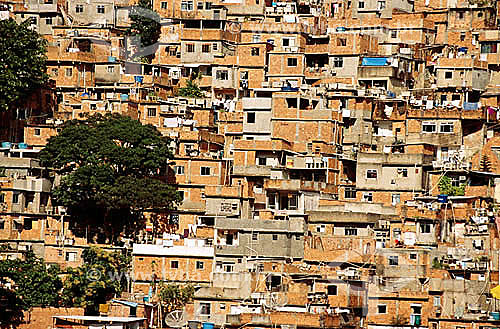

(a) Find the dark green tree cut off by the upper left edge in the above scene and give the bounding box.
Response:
[0,18,48,111]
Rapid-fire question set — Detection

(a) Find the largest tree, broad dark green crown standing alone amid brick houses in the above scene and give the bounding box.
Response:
[40,115,180,242]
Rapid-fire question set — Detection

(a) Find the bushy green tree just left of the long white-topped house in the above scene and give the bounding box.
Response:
[62,247,131,315]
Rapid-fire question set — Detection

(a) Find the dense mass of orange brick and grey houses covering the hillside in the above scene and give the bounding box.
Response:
[0,0,500,329]
